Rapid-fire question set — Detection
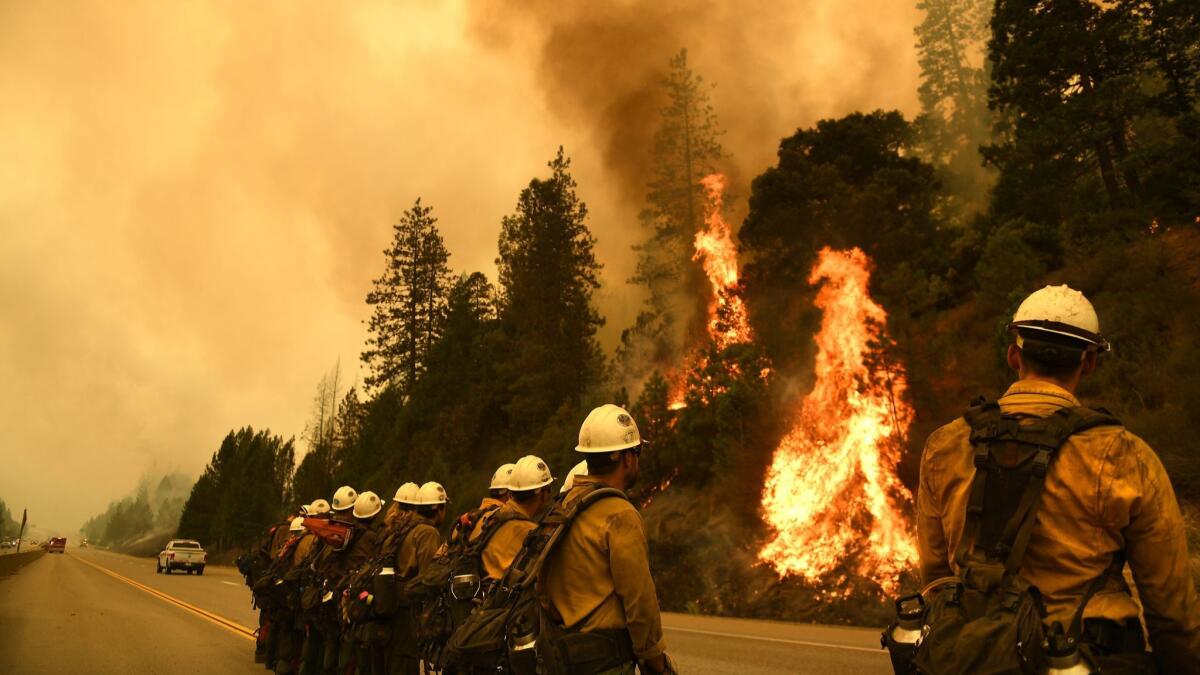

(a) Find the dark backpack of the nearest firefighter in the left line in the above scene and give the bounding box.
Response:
[445,484,634,675]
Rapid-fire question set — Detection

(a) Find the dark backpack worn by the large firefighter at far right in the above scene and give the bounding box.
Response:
[883,401,1124,675]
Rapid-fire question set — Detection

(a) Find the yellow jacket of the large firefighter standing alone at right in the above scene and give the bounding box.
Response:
[917,380,1200,673]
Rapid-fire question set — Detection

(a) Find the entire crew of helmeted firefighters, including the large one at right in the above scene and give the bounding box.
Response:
[239,281,1200,675]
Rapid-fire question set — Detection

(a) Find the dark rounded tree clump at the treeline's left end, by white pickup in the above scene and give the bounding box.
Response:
[178,426,296,551]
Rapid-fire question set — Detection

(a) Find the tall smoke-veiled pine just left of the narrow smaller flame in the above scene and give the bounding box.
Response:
[618,49,722,380]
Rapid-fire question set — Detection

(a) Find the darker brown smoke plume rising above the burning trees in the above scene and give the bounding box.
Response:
[473,0,919,208]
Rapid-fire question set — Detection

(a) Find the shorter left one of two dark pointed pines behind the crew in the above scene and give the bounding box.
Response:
[362,199,451,393]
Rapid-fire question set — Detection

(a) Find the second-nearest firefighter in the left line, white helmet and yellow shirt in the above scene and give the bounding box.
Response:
[481,455,554,581]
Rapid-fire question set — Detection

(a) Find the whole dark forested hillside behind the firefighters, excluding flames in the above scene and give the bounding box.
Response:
[180,0,1200,621]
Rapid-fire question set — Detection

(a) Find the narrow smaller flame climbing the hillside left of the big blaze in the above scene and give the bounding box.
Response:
[670,173,748,410]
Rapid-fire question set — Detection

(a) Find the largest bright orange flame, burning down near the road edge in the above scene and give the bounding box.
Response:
[758,247,917,593]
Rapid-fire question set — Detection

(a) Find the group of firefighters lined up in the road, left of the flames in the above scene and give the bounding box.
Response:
[238,405,674,675]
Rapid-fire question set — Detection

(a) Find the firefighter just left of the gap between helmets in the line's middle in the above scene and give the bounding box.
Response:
[388,482,450,675]
